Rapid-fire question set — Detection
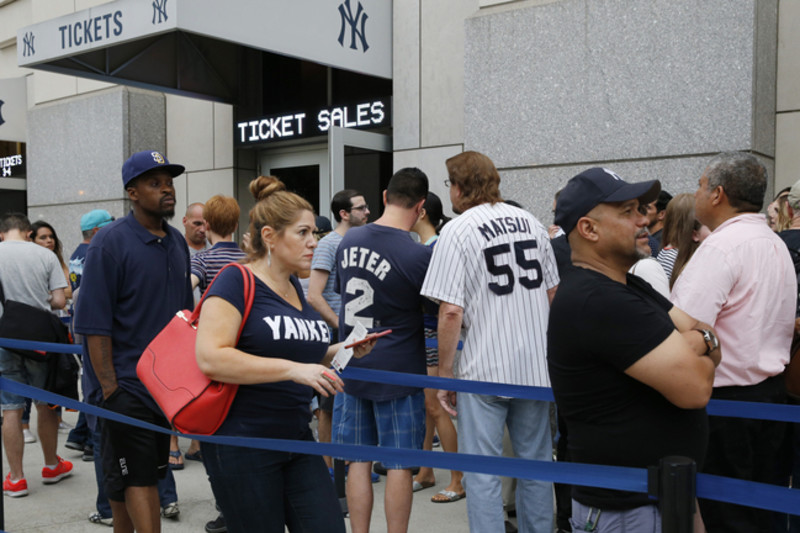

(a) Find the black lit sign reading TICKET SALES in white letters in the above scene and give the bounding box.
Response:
[234,98,391,146]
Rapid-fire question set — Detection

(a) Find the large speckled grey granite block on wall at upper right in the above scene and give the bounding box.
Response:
[464,0,776,168]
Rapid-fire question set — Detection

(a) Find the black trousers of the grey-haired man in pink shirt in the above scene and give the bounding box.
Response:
[700,376,786,533]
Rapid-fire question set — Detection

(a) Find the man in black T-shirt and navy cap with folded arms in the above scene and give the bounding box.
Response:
[547,168,721,533]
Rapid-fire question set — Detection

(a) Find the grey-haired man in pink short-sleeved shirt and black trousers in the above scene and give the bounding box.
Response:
[672,152,797,533]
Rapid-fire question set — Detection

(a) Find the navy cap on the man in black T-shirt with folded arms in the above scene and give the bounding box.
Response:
[555,167,661,235]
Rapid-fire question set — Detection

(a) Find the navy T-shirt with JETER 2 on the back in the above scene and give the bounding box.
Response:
[336,224,431,401]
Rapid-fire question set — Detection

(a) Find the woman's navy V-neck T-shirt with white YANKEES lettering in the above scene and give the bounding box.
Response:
[207,268,330,439]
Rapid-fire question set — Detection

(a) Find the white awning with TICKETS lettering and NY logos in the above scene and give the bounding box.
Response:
[17,0,392,101]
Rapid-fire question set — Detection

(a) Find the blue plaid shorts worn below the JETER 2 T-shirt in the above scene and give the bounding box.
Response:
[332,391,425,470]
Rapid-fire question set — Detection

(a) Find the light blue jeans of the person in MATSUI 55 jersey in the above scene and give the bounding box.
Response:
[457,392,553,533]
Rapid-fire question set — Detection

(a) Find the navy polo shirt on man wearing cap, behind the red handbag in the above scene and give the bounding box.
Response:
[75,212,193,412]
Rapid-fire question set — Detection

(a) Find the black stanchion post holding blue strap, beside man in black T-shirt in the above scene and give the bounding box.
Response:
[647,456,697,533]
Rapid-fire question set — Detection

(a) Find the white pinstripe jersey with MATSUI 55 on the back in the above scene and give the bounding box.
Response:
[422,203,559,387]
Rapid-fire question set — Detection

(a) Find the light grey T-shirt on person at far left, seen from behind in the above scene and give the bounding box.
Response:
[0,241,67,316]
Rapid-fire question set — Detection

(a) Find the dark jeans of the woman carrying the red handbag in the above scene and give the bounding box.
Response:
[200,435,345,533]
